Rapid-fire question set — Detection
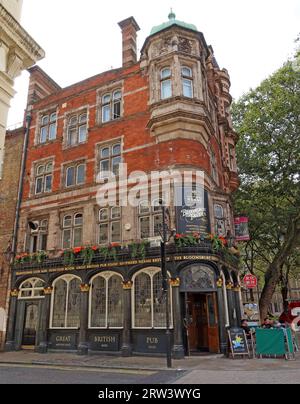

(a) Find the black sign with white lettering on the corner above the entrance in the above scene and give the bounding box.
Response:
[175,187,210,234]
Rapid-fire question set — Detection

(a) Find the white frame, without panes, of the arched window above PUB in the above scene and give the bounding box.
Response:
[131,267,174,330]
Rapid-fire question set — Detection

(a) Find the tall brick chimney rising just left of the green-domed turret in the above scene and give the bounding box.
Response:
[119,17,140,67]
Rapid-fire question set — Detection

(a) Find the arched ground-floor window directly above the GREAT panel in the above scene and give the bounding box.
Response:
[50,275,80,328]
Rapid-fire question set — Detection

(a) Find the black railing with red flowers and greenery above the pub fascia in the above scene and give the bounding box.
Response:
[13,241,238,271]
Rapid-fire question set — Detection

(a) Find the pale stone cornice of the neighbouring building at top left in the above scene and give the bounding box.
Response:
[0,4,45,63]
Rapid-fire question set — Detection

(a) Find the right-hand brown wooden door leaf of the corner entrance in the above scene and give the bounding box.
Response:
[206,293,220,353]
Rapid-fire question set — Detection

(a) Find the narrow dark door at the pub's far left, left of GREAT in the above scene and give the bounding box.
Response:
[22,302,39,349]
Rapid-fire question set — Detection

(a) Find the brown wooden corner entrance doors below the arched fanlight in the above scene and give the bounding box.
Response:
[186,293,220,354]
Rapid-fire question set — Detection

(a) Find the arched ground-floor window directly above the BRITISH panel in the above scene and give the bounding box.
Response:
[89,272,123,329]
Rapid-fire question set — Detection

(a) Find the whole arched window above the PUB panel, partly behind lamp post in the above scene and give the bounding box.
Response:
[132,268,173,329]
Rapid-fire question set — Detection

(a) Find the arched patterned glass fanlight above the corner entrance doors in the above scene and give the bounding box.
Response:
[182,265,215,291]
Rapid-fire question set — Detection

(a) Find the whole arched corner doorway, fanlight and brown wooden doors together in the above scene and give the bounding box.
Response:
[180,264,220,354]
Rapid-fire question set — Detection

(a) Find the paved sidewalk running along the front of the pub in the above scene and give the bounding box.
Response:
[0,351,300,372]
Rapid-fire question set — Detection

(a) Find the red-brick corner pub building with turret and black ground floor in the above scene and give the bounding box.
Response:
[5,13,241,358]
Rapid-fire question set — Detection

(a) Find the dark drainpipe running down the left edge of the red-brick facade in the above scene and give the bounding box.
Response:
[11,112,31,263]
